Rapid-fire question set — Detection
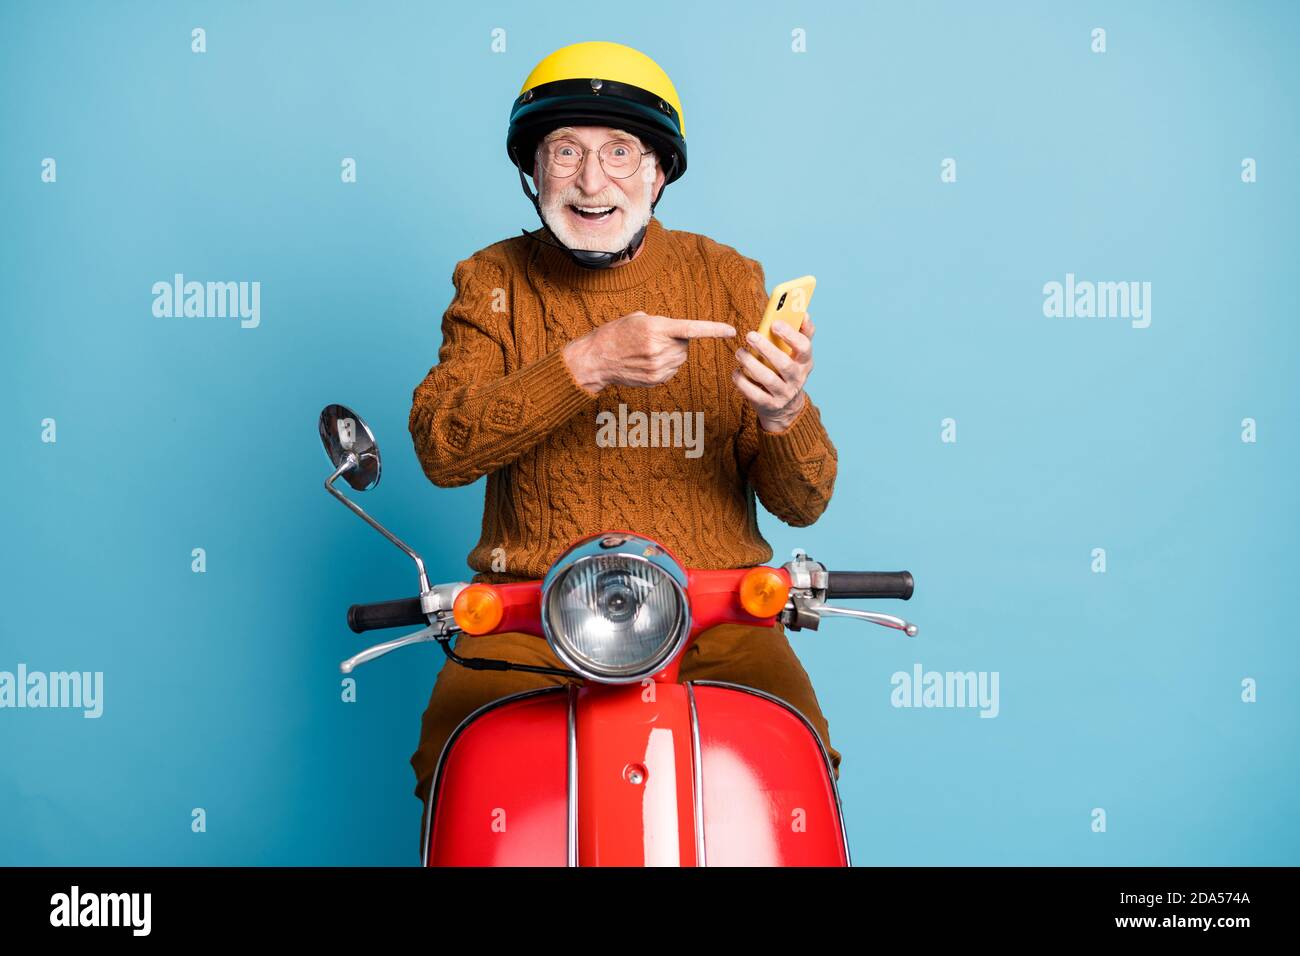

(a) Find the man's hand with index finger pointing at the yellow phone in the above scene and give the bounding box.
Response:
[564,312,736,394]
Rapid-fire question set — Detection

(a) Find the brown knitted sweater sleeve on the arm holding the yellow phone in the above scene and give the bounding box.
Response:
[723,254,839,528]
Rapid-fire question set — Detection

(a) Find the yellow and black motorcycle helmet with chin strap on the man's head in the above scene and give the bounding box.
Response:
[506,40,686,268]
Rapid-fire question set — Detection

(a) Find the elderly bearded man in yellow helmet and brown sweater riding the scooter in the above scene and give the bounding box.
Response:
[410,43,840,858]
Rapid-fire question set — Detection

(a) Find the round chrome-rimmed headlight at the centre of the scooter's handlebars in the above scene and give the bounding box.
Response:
[542,533,690,684]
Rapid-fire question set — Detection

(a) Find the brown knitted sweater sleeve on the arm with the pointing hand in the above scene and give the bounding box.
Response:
[410,255,595,488]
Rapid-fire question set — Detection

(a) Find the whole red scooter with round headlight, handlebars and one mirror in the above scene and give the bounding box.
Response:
[320,405,917,866]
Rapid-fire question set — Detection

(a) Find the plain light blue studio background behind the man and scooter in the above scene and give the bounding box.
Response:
[0,0,1300,865]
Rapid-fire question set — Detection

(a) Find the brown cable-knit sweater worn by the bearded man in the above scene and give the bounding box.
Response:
[410,219,836,583]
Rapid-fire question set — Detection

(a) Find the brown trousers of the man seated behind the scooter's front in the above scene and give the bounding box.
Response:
[411,624,840,848]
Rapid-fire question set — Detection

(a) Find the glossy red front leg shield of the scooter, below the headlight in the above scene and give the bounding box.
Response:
[428,682,849,866]
